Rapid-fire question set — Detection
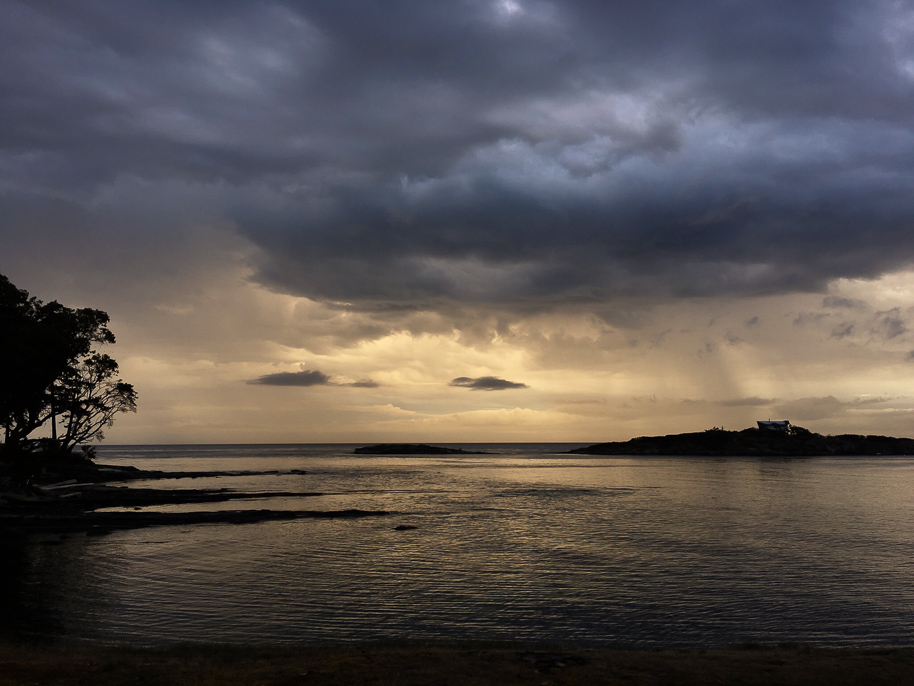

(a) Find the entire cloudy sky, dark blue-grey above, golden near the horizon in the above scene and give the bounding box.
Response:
[0,0,914,443]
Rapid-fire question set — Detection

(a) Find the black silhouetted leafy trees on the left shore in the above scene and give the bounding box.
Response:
[0,274,136,453]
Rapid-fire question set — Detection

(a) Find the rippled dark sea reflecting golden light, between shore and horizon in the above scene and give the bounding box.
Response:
[0,443,914,648]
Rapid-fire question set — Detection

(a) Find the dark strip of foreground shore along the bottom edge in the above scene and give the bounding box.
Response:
[0,642,914,686]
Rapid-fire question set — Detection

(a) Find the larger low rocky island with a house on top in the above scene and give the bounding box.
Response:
[570,422,914,457]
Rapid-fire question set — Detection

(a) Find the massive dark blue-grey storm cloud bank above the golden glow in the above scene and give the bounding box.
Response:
[0,0,914,314]
